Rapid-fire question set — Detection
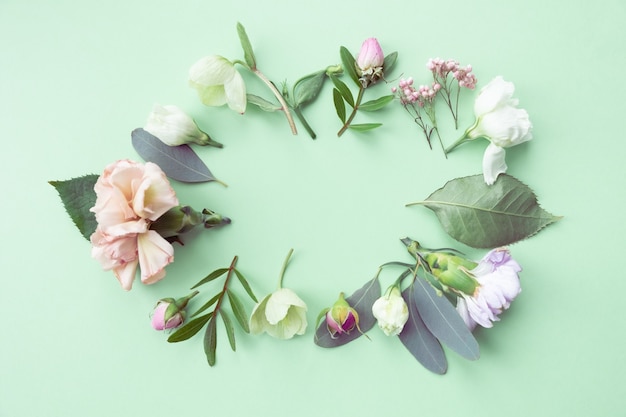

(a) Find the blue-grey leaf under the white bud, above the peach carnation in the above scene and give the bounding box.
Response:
[131,128,218,182]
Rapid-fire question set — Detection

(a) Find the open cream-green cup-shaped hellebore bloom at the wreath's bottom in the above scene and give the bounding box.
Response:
[250,288,307,339]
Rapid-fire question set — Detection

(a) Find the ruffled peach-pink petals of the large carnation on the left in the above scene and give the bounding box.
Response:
[91,160,178,290]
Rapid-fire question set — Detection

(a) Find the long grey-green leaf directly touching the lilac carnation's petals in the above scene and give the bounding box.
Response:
[413,272,480,360]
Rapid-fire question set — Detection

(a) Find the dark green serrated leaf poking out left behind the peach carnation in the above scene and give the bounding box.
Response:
[48,174,98,240]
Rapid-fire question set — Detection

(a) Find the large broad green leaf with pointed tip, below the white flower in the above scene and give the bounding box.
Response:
[408,174,561,248]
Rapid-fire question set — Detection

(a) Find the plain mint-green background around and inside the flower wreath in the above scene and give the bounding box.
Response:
[0,0,626,417]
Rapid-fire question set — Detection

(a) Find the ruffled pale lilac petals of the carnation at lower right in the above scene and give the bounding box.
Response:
[456,248,522,330]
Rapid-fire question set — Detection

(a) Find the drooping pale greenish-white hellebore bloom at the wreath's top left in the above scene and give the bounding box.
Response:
[189,55,246,114]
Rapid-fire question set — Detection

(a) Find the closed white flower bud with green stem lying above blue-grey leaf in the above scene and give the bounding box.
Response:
[143,104,217,146]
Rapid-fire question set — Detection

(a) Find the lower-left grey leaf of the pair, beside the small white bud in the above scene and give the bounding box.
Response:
[398,285,448,375]
